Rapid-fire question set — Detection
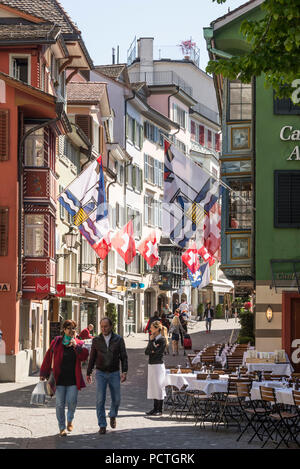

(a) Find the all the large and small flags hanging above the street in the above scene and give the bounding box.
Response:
[58,141,221,268]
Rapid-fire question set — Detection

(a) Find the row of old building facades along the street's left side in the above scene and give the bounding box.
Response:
[0,0,232,381]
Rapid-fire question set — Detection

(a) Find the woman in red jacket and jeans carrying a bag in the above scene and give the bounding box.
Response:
[40,319,88,436]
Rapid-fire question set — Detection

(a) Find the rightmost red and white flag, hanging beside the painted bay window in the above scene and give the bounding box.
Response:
[203,202,221,260]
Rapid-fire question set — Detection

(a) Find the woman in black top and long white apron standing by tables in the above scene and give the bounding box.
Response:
[145,321,166,415]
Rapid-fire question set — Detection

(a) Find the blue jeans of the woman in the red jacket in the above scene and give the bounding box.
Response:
[55,386,78,431]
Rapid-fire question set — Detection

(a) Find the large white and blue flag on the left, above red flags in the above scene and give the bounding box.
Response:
[58,157,109,248]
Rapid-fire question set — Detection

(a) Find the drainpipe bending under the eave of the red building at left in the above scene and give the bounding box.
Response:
[17,116,60,298]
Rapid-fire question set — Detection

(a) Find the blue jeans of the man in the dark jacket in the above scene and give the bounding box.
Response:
[96,370,121,427]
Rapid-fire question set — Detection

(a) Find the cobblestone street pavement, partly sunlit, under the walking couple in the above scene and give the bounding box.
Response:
[0,319,268,450]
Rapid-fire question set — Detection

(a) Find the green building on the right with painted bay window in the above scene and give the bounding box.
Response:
[204,0,300,360]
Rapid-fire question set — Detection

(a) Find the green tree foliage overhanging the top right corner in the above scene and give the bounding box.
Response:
[206,0,300,98]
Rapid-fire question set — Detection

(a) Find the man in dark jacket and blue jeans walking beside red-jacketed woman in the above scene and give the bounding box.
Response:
[86,318,128,435]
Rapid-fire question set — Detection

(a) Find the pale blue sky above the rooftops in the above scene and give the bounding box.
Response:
[60,0,247,69]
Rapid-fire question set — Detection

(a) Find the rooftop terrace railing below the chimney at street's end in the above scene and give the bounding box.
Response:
[129,71,193,96]
